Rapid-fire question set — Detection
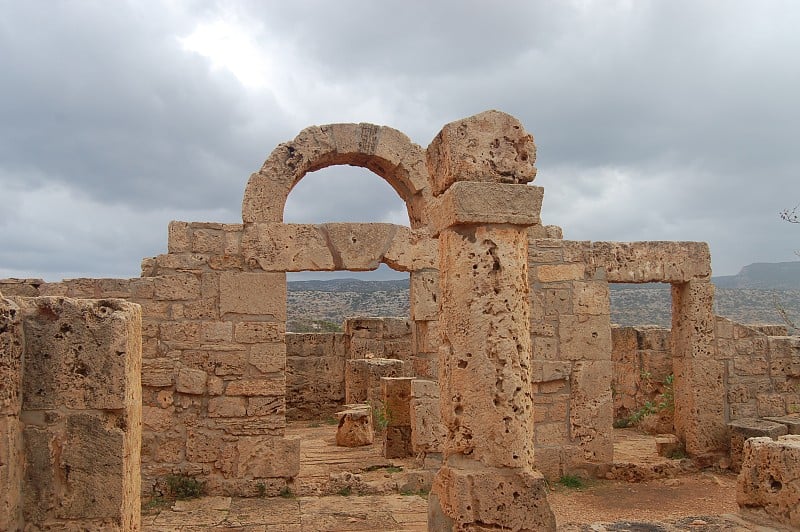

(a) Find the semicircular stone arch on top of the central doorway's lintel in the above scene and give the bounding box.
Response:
[242,123,431,228]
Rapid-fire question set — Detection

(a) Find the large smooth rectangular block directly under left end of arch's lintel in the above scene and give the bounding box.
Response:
[219,272,286,321]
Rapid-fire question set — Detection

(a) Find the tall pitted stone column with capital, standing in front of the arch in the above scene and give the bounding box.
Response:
[428,111,555,531]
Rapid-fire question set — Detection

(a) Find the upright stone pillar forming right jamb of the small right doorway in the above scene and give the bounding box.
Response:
[672,279,727,458]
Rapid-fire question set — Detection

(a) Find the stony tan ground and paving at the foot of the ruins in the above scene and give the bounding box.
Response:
[142,422,786,532]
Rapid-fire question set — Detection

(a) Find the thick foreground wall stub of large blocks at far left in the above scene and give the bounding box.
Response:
[0,296,141,530]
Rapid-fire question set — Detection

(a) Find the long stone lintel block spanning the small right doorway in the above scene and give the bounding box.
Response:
[592,242,711,283]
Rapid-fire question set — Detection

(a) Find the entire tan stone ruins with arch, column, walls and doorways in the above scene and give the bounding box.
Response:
[0,111,800,531]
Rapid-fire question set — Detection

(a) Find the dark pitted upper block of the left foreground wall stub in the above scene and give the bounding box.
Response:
[22,297,136,410]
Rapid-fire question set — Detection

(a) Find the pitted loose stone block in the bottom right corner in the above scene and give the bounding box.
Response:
[736,435,800,528]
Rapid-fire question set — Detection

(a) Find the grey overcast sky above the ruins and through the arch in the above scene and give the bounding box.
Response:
[0,0,800,280]
